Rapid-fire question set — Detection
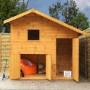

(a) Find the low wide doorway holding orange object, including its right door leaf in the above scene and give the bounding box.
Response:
[20,54,51,79]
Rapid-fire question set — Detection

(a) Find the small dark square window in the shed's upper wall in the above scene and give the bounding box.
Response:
[28,30,39,40]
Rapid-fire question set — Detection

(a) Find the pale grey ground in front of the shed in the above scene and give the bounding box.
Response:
[0,73,90,90]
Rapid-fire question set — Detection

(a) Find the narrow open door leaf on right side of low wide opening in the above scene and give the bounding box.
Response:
[46,55,51,80]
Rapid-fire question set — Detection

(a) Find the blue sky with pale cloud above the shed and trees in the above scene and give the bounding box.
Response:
[26,0,90,22]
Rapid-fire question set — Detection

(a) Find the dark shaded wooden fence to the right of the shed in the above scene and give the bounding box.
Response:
[80,28,90,80]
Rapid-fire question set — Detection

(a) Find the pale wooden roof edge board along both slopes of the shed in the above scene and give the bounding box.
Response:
[4,9,87,35]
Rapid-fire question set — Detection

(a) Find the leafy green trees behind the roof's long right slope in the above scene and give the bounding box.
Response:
[49,0,89,30]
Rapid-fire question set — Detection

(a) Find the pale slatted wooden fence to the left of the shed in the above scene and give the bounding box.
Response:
[0,33,10,72]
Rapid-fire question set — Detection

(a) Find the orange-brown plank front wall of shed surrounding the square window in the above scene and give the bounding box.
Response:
[10,14,78,79]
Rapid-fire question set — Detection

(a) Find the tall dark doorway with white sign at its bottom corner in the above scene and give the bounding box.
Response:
[56,38,72,79]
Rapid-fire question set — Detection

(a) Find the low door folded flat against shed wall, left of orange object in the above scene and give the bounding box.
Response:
[9,54,20,79]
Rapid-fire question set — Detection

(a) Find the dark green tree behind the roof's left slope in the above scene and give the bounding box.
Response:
[0,0,26,32]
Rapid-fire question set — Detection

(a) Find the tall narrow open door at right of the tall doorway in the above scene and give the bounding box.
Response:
[72,38,79,82]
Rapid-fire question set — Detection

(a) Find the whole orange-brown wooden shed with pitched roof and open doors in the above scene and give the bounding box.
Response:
[4,9,86,81]
